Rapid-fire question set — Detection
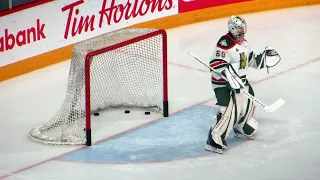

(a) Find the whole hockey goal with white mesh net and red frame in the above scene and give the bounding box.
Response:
[29,29,168,145]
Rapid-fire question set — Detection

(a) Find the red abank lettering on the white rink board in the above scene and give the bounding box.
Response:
[0,19,46,52]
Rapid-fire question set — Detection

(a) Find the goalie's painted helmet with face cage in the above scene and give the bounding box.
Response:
[228,15,247,42]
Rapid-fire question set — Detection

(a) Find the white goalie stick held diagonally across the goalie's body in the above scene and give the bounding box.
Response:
[188,51,285,112]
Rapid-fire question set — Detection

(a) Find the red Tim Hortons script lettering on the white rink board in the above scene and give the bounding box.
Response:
[61,0,173,39]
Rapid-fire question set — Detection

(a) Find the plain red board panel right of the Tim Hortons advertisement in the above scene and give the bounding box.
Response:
[179,0,252,13]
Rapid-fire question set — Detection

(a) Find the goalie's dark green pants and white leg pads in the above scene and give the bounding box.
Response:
[207,82,259,148]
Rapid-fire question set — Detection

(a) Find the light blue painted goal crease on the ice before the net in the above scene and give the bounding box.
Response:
[58,106,250,164]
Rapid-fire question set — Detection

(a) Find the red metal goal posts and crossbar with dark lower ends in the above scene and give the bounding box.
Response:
[84,29,169,146]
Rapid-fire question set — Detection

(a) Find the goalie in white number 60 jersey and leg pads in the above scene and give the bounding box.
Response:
[205,15,281,154]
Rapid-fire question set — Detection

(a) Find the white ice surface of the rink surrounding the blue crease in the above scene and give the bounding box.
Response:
[0,5,320,180]
